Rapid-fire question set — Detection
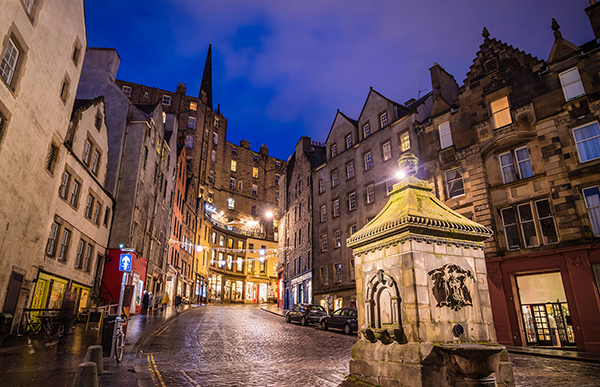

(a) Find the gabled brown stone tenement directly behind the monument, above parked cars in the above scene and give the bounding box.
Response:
[310,89,436,311]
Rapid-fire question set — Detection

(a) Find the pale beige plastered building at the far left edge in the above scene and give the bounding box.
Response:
[0,0,87,328]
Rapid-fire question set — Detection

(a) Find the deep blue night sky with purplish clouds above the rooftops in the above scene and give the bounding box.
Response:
[85,0,593,160]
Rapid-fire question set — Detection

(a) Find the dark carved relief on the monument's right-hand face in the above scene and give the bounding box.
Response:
[428,263,473,311]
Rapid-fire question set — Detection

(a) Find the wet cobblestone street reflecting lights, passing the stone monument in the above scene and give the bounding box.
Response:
[138,305,600,387]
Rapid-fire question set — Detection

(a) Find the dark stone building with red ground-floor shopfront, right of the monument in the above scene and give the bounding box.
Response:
[419,1,600,352]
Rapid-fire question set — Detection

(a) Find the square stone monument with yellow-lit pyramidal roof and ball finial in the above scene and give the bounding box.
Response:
[348,153,514,387]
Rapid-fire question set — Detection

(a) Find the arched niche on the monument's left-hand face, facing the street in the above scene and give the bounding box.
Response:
[362,270,406,344]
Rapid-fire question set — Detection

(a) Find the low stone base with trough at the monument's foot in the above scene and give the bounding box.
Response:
[350,340,515,387]
